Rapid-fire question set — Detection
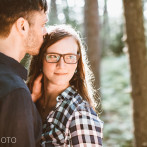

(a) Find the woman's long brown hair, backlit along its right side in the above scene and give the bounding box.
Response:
[27,25,99,105]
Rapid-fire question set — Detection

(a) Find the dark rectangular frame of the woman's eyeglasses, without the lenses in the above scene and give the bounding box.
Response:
[44,52,80,64]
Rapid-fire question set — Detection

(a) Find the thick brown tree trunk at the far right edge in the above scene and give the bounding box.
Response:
[123,0,147,147]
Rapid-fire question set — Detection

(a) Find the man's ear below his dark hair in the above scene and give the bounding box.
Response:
[15,17,29,36]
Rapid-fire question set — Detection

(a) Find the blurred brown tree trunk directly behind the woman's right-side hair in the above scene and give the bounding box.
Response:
[84,0,101,88]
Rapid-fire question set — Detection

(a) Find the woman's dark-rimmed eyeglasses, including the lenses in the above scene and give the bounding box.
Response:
[45,53,80,64]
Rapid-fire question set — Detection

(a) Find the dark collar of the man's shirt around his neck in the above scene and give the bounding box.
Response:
[0,52,27,80]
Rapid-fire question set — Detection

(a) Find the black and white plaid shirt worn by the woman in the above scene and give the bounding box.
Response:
[41,87,103,147]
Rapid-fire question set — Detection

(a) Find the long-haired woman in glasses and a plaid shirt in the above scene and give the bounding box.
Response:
[28,25,103,147]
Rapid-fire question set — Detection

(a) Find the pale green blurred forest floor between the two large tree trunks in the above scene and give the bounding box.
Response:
[101,55,133,147]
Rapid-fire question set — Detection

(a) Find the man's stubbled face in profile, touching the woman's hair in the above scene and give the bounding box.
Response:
[23,11,48,55]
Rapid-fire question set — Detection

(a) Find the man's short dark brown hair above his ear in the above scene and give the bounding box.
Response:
[0,0,47,37]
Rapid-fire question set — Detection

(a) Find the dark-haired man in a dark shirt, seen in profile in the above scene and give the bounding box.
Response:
[0,0,47,147]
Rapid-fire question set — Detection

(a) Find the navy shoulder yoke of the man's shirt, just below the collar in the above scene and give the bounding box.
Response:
[0,65,28,97]
